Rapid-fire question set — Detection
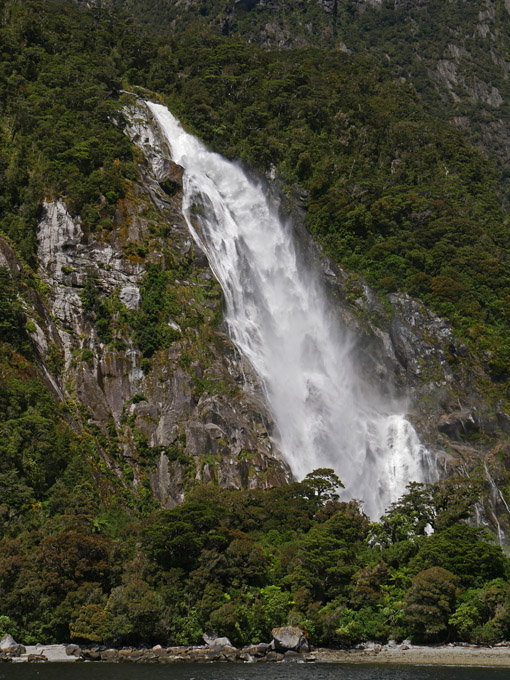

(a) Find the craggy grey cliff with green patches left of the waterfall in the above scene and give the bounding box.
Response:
[2,95,291,507]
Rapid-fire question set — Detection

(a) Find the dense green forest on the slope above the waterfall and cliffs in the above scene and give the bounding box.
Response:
[2,3,510,380]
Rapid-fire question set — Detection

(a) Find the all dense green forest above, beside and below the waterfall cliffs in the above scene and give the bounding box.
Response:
[0,0,510,645]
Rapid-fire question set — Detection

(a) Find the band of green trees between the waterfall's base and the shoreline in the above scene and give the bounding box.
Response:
[0,470,510,645]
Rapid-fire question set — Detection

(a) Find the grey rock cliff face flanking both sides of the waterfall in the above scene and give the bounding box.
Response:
[1,79,510,529]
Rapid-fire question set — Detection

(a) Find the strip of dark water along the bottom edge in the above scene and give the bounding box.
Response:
[0,663,510,680]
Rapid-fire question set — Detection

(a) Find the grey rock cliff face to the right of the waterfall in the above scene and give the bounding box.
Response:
[322,252,510,542]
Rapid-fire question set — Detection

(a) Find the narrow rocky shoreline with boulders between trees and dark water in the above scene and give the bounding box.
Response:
[0,628,510,667]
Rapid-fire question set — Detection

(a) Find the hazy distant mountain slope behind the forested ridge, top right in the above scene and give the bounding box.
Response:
[110,0,510,203]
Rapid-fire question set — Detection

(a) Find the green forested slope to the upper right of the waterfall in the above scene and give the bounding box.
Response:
[142,30,510,381]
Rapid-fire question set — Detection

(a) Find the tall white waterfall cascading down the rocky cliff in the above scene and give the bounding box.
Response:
[148,103,428,518]
